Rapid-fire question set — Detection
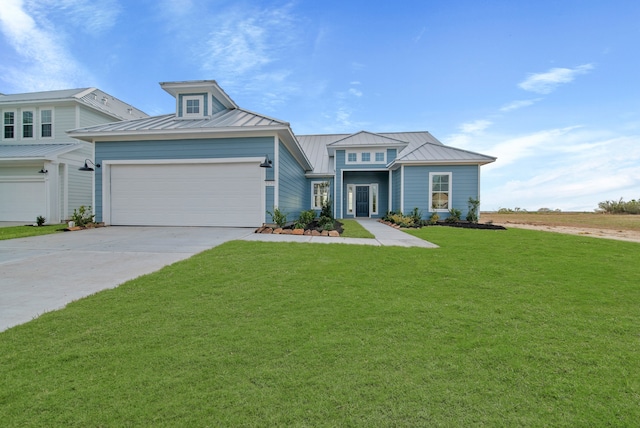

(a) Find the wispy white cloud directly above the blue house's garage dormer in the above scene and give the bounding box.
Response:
[192,4,301,111]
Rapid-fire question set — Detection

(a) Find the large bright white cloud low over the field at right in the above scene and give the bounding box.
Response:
[482,127,640,211]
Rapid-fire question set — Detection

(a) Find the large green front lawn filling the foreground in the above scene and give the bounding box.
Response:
[0,227,640,427]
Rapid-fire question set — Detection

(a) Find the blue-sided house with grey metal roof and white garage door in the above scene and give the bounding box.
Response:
[69,80,495,227]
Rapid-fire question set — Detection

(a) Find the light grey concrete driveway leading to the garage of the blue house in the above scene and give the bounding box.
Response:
[0,227,253,331]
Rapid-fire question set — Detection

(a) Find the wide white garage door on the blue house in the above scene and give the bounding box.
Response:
[110,162,264,227]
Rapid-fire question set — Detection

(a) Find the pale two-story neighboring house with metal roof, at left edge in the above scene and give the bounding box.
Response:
[0,88,148,223]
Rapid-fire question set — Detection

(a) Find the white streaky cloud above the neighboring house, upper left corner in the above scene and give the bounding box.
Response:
[0,0,91,92]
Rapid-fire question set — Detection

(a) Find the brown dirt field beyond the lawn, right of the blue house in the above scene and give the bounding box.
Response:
[480,212,640,243]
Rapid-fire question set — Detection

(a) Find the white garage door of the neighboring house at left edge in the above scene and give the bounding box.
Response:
[0,181,46,223]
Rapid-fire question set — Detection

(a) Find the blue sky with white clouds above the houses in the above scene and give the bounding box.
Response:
[0,0,640,211]
